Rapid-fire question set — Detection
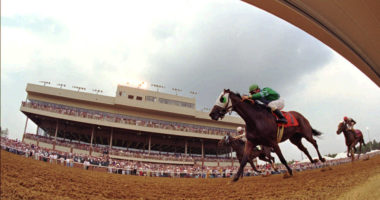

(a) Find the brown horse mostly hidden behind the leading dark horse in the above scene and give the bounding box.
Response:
[218,134,277,175]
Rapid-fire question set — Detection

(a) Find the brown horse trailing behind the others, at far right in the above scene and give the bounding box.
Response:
[336,122,365,161]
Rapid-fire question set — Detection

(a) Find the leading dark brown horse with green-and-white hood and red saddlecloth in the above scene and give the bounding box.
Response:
[210,89,325,181]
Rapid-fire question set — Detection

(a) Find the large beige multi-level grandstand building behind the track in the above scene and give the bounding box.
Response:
[20,84,244,166]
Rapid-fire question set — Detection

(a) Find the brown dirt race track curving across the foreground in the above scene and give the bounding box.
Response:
[1,150,380,200]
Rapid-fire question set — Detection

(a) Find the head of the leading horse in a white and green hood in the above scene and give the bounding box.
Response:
[209,89,232,120]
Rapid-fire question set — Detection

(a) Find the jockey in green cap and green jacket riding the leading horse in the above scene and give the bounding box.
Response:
[242,84,288,124]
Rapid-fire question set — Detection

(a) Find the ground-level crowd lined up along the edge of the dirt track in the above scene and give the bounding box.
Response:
[1,137,379,178]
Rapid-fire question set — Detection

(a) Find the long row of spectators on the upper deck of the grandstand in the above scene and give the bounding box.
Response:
[22,100,236,135]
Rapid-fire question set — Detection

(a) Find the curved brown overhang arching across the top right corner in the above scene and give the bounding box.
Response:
[243,0,380,86]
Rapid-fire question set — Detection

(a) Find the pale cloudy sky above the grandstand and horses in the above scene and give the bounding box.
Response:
[1,0,380,160]
